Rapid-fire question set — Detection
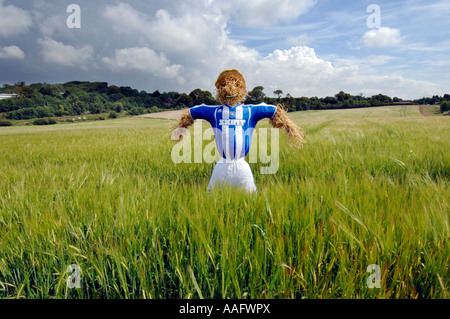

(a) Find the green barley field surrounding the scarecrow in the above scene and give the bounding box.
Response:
[0,106,450,299]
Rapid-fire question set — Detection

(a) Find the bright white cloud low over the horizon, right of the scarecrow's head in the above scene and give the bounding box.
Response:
[220,46,442,97]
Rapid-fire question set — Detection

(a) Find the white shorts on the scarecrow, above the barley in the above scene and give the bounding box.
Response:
[208,158,256,193]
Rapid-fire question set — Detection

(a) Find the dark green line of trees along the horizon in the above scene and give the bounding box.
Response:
[0,81,450,120]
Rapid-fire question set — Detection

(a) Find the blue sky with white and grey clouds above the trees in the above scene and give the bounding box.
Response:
[0,0,450,99]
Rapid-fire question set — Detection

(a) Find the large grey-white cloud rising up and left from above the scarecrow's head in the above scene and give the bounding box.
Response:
[100,3,258,80]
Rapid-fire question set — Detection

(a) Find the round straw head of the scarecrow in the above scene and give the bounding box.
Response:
[216,69,247,106]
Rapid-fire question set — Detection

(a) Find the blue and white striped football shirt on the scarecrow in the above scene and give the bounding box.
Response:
[189,103,277,160]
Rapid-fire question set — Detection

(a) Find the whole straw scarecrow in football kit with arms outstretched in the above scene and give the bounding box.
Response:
[173,69,304,192]
